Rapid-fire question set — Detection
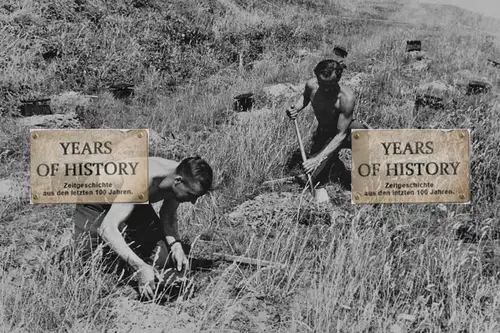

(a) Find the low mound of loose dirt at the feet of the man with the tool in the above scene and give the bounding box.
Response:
[228,191,346,227]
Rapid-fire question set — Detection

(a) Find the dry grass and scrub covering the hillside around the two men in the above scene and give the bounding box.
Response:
[0,0,500,333]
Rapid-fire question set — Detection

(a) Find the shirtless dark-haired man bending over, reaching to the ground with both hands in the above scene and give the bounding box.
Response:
[74,156,213,299]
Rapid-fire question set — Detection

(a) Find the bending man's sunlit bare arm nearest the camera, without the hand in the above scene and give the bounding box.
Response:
[97,203,146,270]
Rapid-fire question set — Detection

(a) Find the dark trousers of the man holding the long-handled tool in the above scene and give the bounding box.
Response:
[309,120,368,190]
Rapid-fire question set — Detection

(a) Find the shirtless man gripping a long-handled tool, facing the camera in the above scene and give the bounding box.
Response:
[286,60,369,190]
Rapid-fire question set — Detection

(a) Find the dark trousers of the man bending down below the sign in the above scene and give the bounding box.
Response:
[74,204,178,269]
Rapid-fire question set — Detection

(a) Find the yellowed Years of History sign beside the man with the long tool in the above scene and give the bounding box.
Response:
[351,129,470,204]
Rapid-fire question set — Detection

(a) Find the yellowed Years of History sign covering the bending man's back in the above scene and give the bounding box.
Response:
[30,129,149,204]
